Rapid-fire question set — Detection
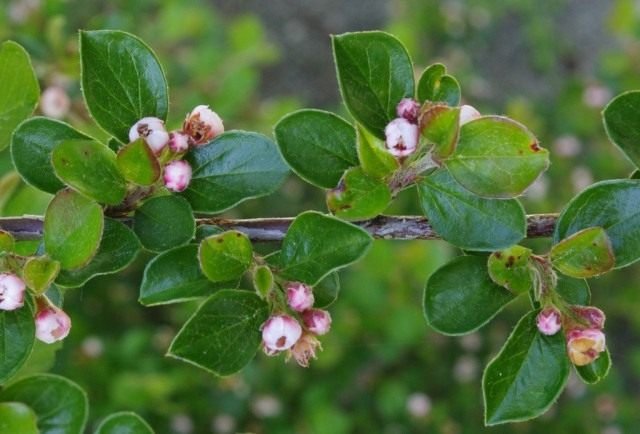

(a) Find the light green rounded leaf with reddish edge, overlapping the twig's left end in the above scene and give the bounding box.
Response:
[44,190,104,270]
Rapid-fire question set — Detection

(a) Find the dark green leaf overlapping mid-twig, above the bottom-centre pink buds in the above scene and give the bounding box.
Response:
[279,211,372,286]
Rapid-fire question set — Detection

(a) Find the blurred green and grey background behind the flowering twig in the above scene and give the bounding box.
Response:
[0,0,640,434]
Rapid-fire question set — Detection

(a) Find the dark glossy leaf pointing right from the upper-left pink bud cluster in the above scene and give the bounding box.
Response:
[182,131,288,213]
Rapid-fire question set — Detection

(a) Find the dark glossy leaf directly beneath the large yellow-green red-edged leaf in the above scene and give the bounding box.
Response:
[417,170,526,251]
